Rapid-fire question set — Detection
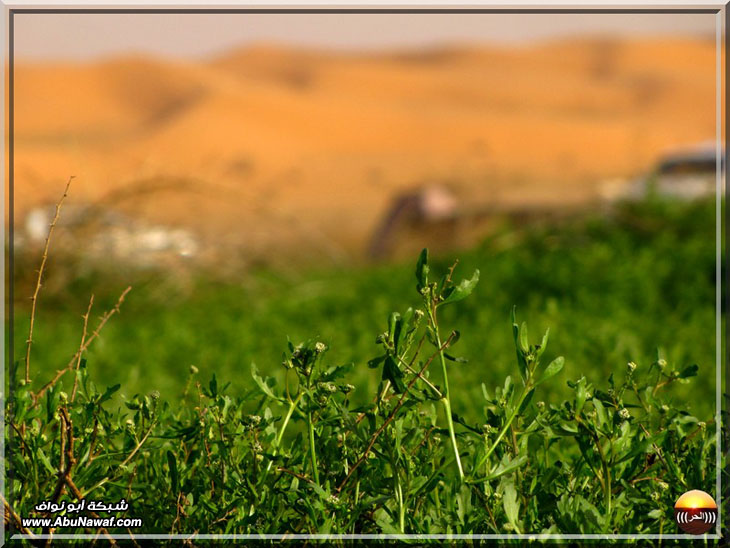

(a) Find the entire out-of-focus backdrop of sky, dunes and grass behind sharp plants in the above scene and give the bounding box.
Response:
[6,14,724,424]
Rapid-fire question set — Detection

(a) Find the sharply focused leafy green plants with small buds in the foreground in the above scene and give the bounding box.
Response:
[5,250,716,535]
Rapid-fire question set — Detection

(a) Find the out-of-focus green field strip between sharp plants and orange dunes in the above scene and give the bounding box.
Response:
[15,196,716,420]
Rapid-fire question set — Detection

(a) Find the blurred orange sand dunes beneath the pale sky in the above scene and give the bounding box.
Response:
[14,34,715,266]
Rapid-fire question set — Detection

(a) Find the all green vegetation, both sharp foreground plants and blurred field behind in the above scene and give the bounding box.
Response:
[6,198,728,535]
